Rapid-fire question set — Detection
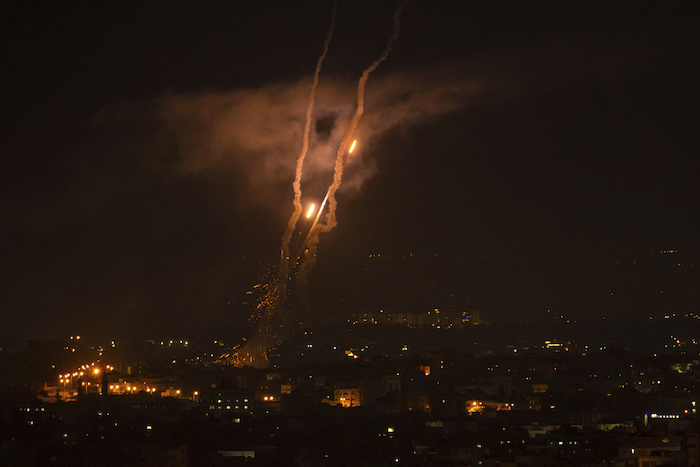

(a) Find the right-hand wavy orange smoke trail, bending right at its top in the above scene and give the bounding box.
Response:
[298,0,408,288]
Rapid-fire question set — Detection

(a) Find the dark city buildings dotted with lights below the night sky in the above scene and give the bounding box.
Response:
[0,324,700,467]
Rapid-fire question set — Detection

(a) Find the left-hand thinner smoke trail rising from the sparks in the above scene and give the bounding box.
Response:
[277,0,338,305]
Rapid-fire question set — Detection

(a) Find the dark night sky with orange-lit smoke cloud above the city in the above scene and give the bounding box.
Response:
[0,0,700,346]
